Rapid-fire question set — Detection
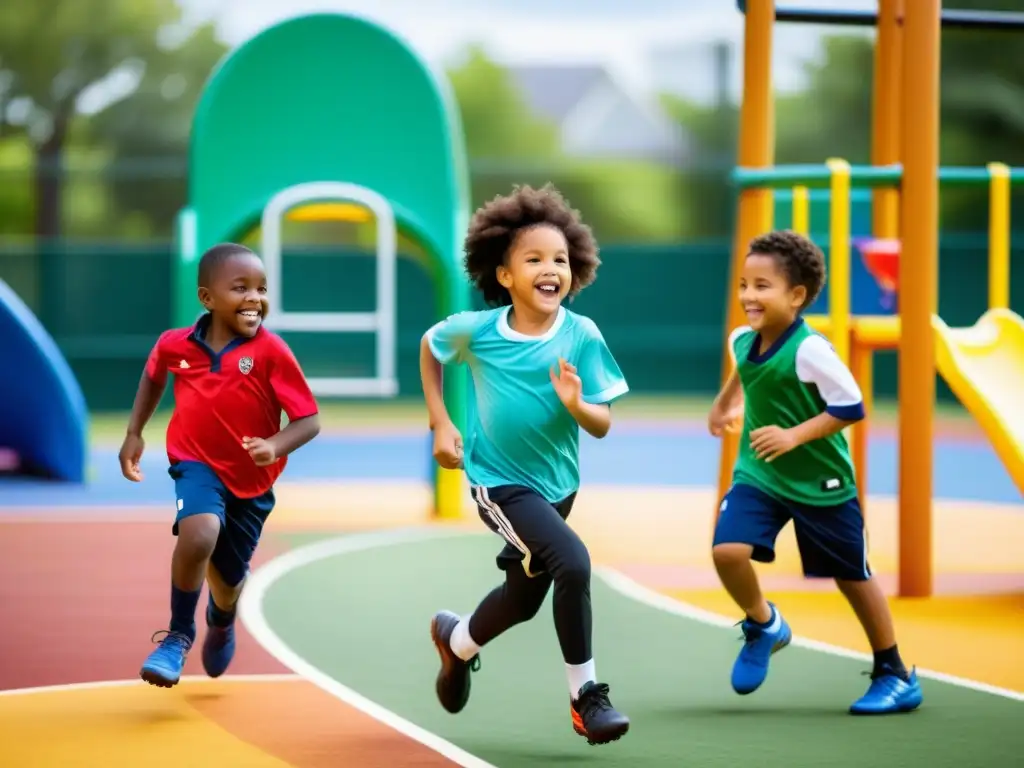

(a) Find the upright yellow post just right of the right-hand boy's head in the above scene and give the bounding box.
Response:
[827,158,850,366]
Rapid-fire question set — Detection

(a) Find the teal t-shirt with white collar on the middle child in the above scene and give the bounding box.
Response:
[427,306,629,503]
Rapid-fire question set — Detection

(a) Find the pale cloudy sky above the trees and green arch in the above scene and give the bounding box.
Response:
[172,0,876,100]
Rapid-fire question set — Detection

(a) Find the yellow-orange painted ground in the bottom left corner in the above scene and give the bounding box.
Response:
[0,676,453,768]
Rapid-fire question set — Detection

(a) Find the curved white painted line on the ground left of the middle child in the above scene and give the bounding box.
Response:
[239,527,495,768]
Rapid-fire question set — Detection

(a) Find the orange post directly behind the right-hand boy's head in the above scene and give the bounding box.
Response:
[716,0,775,514]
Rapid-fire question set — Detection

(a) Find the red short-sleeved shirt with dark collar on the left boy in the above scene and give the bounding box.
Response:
[145,315,317,499]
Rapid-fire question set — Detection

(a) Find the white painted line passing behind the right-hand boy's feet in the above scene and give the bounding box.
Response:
[594,567,1024,701]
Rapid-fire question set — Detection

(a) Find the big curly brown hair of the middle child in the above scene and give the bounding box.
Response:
[463,183,601,306]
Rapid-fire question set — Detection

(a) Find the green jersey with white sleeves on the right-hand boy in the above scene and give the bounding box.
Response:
[729,319,864,507]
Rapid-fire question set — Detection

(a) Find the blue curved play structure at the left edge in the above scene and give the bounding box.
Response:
[0,280,89,482]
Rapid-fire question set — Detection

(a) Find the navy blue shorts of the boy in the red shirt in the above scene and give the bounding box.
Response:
[167,462,273,587]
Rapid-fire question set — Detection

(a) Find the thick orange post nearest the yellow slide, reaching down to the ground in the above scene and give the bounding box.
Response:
[899,0,942,597]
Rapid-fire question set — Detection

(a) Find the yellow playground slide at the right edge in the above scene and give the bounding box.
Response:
[932,309,1024,494]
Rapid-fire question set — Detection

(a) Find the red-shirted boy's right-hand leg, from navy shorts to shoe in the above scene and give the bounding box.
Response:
[197,490,274,677]
